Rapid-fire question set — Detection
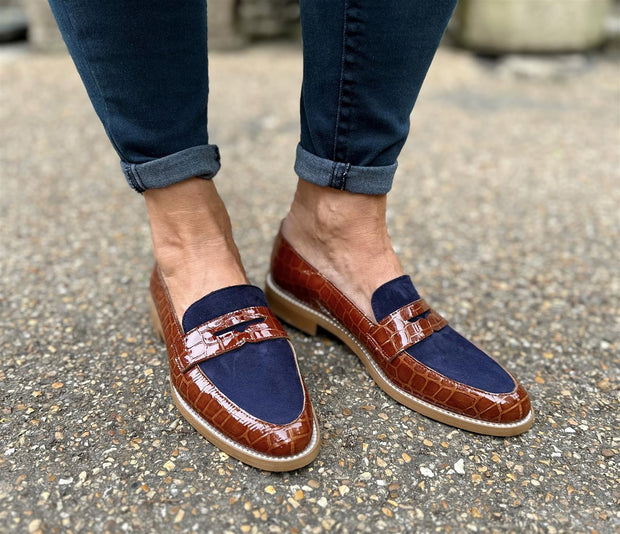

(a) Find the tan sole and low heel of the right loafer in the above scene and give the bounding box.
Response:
[265,274,534,436]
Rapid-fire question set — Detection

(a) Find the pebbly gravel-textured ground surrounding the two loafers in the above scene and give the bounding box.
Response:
[0,45,620,533]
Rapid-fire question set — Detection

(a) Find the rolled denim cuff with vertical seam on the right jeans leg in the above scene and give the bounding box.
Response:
[295,145,398,195]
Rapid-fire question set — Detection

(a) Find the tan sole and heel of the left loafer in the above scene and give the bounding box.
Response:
[149,296,321,472]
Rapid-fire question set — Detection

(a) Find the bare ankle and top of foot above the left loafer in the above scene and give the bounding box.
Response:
[144,178,248,320]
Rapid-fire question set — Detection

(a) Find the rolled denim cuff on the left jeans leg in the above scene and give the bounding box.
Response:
[121,145,220,193]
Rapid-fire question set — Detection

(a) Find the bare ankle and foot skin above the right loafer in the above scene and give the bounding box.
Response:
[282,180,404,318]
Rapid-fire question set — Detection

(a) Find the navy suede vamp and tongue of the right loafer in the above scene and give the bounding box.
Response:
[371,275,515,393]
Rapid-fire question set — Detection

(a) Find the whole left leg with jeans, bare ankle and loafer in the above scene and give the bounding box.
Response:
[52,0,320,471]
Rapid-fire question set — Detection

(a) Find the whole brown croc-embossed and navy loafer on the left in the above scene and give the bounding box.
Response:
[150,267,320,471]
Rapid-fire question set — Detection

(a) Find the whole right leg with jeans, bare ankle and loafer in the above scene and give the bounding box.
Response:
[266,0,533,436]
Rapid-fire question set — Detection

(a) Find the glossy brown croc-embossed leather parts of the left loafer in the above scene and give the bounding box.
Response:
[150,266,313,457]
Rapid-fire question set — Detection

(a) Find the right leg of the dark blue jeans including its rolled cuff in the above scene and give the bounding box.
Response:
[295,0,456,194]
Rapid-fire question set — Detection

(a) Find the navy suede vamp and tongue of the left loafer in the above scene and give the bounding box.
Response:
[183,285,304,425]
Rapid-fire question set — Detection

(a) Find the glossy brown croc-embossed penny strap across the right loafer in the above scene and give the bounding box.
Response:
[371,299,448,362]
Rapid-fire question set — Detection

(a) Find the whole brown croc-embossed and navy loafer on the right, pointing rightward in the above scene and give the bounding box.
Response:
[266,234,534,436]
